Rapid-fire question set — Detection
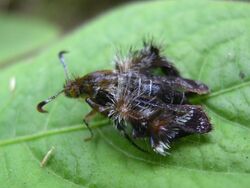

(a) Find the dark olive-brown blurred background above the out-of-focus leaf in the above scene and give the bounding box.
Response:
[0,0,133,31]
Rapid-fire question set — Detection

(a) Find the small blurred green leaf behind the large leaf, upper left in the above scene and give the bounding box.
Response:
[0,13,59,66]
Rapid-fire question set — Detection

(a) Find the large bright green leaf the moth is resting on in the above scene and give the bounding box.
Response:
[0,1,250,188]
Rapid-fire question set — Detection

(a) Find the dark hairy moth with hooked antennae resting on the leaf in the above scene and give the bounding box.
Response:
[37,42,212,155]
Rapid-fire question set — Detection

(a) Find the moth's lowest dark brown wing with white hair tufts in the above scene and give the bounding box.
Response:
[150,105,212,155]
